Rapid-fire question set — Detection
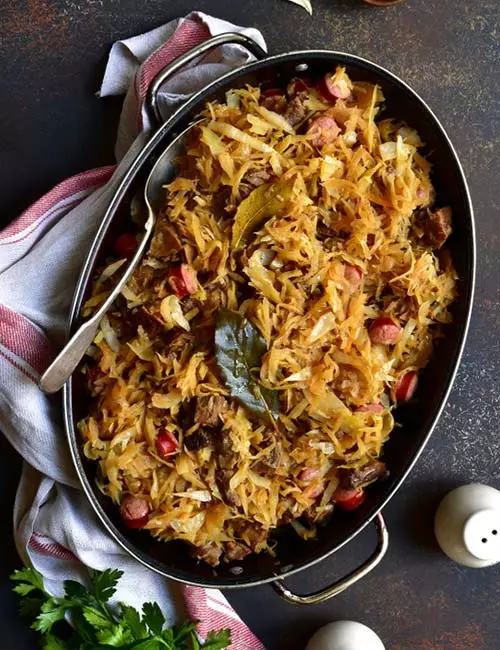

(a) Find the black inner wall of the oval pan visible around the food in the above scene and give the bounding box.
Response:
[65,52,474,587]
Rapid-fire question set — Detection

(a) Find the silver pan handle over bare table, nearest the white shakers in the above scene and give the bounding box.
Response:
[271,513,389,605]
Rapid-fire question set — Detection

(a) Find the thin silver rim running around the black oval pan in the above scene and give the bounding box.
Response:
[63,50,476,589]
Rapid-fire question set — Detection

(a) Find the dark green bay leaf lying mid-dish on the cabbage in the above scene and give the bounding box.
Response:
[215,309,279,426]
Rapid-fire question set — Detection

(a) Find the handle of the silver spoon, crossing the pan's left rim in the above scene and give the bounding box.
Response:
[38,214,154,393]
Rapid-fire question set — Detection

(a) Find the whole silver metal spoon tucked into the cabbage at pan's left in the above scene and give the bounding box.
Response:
[38,120,201,393]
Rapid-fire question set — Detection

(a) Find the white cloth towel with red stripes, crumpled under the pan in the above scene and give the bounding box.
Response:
[0,13,265,650]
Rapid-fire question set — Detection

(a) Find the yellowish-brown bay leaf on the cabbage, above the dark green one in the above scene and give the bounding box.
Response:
[232,178,294,249]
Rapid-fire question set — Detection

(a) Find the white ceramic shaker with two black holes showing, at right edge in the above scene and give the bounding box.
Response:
[434,483,500,568]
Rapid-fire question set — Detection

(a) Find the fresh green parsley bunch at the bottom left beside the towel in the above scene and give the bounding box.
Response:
[11,568,231,650]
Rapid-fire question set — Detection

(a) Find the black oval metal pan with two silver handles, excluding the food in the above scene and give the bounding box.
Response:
[63,34,475,603]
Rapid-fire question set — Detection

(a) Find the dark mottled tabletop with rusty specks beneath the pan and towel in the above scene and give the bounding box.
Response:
[0,0,500,650]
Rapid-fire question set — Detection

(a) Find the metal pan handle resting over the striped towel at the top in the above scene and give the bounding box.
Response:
[146,32,267,124]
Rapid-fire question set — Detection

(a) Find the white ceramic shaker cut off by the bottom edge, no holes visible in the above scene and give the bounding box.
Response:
[306,621,385,650]
